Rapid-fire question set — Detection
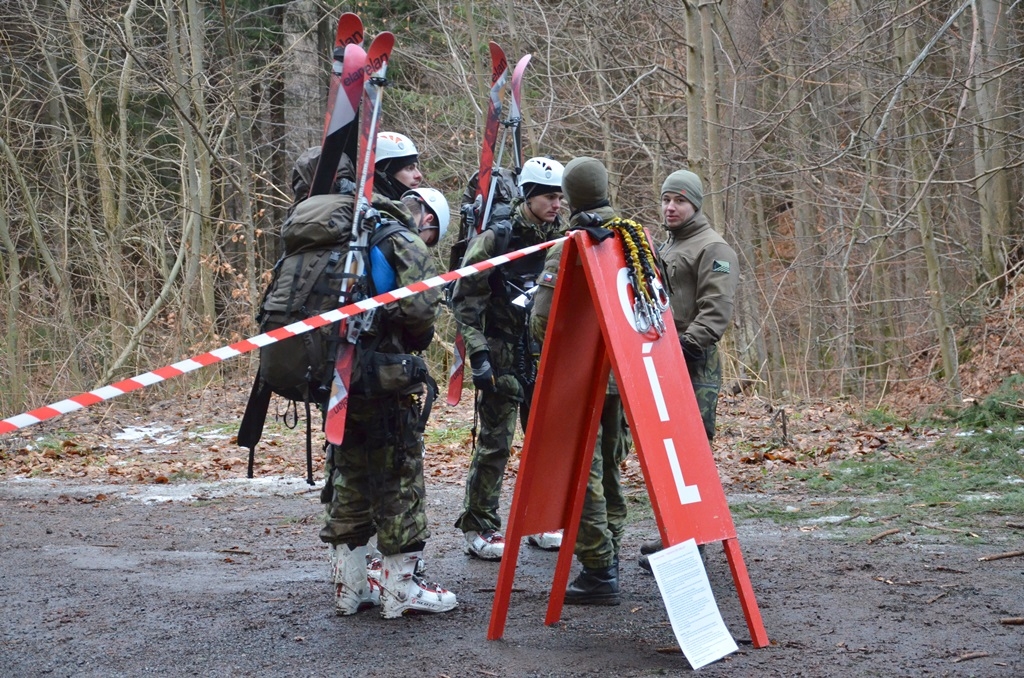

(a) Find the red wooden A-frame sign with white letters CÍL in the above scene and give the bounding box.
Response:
[487,231,768,647]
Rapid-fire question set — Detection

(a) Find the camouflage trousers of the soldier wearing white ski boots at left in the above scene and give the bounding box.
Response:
[319,396,430,555]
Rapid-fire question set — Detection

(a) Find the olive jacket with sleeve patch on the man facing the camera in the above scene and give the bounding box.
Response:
[658,212,739,348]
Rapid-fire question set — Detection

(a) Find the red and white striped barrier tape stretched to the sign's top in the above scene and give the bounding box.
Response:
[0,238,565,435]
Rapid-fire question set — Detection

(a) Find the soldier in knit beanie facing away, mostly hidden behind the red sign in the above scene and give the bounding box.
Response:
[530,157,630,605]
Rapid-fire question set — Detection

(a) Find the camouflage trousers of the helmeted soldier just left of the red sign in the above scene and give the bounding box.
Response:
[455,375,523,533]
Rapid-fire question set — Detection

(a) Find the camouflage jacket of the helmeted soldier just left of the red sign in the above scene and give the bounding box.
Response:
[452,200,559,360]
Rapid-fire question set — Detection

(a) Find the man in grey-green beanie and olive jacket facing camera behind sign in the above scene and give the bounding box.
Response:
[640,170,739,571]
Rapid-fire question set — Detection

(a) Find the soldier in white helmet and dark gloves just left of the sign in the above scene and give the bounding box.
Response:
[452,158,562,560]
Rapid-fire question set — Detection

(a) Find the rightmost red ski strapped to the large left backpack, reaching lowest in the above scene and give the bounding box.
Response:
[324,32,394,444]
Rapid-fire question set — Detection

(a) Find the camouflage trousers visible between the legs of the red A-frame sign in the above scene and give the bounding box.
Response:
[575,393,631,569]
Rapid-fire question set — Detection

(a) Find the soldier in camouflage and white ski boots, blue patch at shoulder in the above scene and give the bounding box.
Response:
[309,146,457,619]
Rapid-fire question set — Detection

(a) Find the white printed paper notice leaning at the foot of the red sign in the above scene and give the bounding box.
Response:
[648,539,737,670]
